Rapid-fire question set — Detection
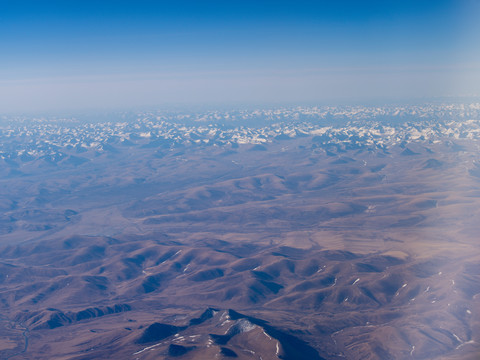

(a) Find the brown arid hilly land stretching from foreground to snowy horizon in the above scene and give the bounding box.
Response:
[0,105,480,360]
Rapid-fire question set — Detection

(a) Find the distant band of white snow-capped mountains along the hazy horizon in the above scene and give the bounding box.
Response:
[0,103,480,162]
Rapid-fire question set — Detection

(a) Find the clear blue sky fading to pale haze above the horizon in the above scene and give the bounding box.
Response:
[0,0,480,112]
